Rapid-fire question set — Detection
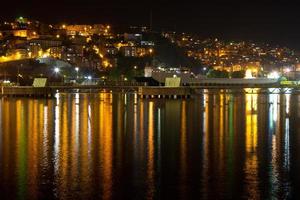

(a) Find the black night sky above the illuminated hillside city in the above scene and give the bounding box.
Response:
[0,0,300,50]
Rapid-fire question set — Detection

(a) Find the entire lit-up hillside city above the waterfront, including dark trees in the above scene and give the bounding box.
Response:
[0,17,300,85]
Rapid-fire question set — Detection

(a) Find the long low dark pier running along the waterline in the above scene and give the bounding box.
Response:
[0,85,300,99]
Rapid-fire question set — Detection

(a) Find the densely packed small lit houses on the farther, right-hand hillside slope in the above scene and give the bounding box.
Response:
[163,32,300,76]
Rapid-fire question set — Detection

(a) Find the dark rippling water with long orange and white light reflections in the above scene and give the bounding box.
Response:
[0,91,300,200]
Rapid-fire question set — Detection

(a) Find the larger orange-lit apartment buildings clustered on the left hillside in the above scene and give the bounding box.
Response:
[0,17,154,70]
